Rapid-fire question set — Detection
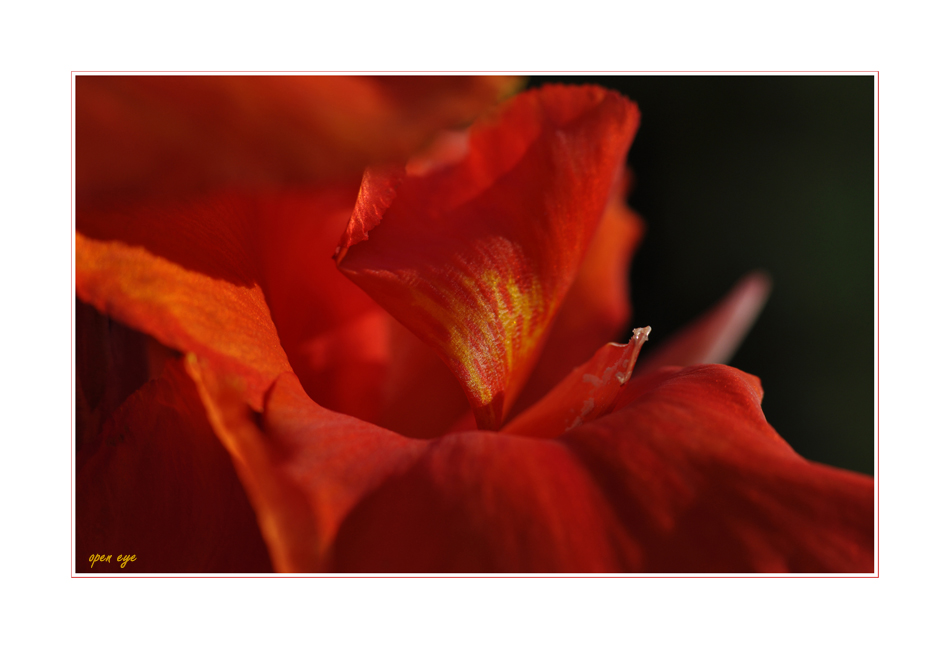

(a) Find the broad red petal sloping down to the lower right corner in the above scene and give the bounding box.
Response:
[563,365,874,572]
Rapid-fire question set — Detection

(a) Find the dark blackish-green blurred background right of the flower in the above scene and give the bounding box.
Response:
[531,76,875,474]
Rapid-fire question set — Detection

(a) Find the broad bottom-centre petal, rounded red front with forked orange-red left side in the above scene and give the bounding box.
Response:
[188,352,621,572]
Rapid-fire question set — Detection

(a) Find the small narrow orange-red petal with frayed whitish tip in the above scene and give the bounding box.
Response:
[501,327,650,437]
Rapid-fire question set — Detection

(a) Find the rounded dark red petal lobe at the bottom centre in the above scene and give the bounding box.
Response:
[333,432,632,573]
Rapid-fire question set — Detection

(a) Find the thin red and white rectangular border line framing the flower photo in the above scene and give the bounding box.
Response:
[69,70,881,579]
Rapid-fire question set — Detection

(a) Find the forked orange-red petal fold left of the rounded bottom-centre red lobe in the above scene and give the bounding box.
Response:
[187,356,422,572]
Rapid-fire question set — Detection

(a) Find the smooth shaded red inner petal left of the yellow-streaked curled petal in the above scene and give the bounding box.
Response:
[256,185,391,421]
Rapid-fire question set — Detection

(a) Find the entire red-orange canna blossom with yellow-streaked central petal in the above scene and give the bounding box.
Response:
[76,77,874,573]
